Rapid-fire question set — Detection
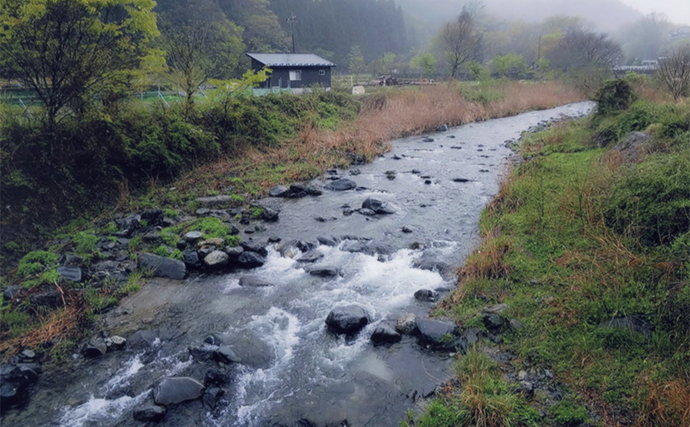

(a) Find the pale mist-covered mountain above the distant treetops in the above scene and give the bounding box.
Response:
[397,0,643,32]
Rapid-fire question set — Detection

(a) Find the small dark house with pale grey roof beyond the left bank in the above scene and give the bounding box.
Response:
[247,53,335,94]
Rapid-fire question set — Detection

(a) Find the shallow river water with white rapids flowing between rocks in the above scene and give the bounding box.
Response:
[3,103,593,427]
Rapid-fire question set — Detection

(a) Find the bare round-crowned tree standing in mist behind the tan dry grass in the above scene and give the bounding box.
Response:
[439,7,482,77]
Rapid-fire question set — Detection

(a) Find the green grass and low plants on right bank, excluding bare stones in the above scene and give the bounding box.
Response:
[428,103,690,427]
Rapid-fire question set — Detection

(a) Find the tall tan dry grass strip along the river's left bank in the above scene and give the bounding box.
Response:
[177,82,584,194]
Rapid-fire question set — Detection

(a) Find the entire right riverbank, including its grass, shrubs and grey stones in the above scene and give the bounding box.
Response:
[408,85,690,427]
